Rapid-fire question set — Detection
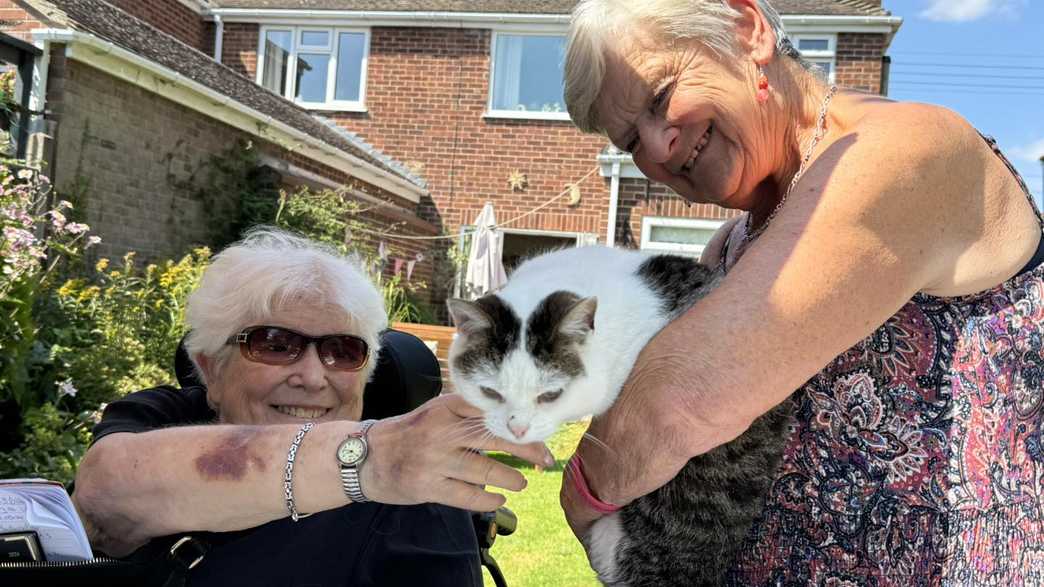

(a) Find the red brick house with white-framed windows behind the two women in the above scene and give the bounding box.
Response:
[0,0,901,315]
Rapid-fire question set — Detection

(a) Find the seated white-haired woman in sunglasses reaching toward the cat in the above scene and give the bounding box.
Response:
[73,230,550,585]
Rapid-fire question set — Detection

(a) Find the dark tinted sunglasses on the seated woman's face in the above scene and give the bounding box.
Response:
[224,326,370,371]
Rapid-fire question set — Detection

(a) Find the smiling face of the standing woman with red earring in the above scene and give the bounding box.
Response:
[595,32,779,210]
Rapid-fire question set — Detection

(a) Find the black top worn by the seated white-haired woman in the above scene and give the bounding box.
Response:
[94,385,482,587]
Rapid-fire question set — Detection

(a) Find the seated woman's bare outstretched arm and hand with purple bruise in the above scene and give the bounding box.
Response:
[73,396,549,557]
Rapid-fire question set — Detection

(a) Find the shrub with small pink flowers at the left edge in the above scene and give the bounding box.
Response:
[0,160,98,480]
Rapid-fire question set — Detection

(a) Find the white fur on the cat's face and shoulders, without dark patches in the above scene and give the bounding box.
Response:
[450,242,668,442]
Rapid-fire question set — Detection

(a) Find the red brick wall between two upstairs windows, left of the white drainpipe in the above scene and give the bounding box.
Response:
[333,28,608,240]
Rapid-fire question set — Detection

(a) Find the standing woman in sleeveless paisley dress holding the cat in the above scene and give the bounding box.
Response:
[562,0,1044,586]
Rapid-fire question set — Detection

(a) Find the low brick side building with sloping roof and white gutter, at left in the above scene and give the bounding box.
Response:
[0,0,438,290]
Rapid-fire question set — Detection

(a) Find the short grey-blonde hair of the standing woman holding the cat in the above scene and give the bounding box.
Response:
[565,0,797,133]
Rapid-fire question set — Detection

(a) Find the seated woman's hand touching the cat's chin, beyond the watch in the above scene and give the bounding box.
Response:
[360,394,554,512]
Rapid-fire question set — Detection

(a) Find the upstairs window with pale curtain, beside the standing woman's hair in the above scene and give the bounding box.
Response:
[487,32,569,120]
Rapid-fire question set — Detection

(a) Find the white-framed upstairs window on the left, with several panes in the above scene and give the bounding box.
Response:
[257,27,370,111]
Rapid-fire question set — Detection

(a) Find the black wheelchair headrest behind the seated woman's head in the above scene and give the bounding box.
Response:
[174,330,443,420]
